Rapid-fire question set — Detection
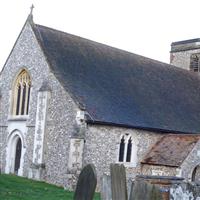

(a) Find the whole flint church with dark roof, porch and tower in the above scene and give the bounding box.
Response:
[0,14,200,189]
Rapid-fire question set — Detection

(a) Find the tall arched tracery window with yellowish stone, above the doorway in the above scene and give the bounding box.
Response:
[12,70,31,115]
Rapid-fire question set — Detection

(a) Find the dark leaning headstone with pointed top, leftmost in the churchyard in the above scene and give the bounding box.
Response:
[74,164,97,200]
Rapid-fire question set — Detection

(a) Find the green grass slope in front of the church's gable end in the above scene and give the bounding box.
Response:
[0,174,100,200]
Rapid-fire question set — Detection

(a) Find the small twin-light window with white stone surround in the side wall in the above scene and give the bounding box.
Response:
[118,135,132,162]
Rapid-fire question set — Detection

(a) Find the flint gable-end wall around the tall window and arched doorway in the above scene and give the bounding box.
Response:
[0,23,79,186]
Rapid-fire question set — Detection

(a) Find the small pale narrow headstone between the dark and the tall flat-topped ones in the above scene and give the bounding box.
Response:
[101,174,112,200]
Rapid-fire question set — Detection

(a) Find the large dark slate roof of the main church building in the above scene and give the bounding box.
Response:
[32,25,200,133]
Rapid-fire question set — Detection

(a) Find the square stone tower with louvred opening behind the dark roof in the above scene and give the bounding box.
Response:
[170,38,200,72]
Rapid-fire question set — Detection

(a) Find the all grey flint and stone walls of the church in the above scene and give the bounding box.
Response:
[0,16,200,190]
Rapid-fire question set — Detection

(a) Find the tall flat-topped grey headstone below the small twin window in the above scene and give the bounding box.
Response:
[110,164,128,200]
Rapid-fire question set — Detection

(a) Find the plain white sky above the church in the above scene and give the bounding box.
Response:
[0,0,200,69]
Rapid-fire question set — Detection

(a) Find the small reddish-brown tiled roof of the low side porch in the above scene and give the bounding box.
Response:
[141,135,199,167]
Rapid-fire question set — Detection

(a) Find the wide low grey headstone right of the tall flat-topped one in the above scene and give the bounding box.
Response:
[129,180,163,200]
